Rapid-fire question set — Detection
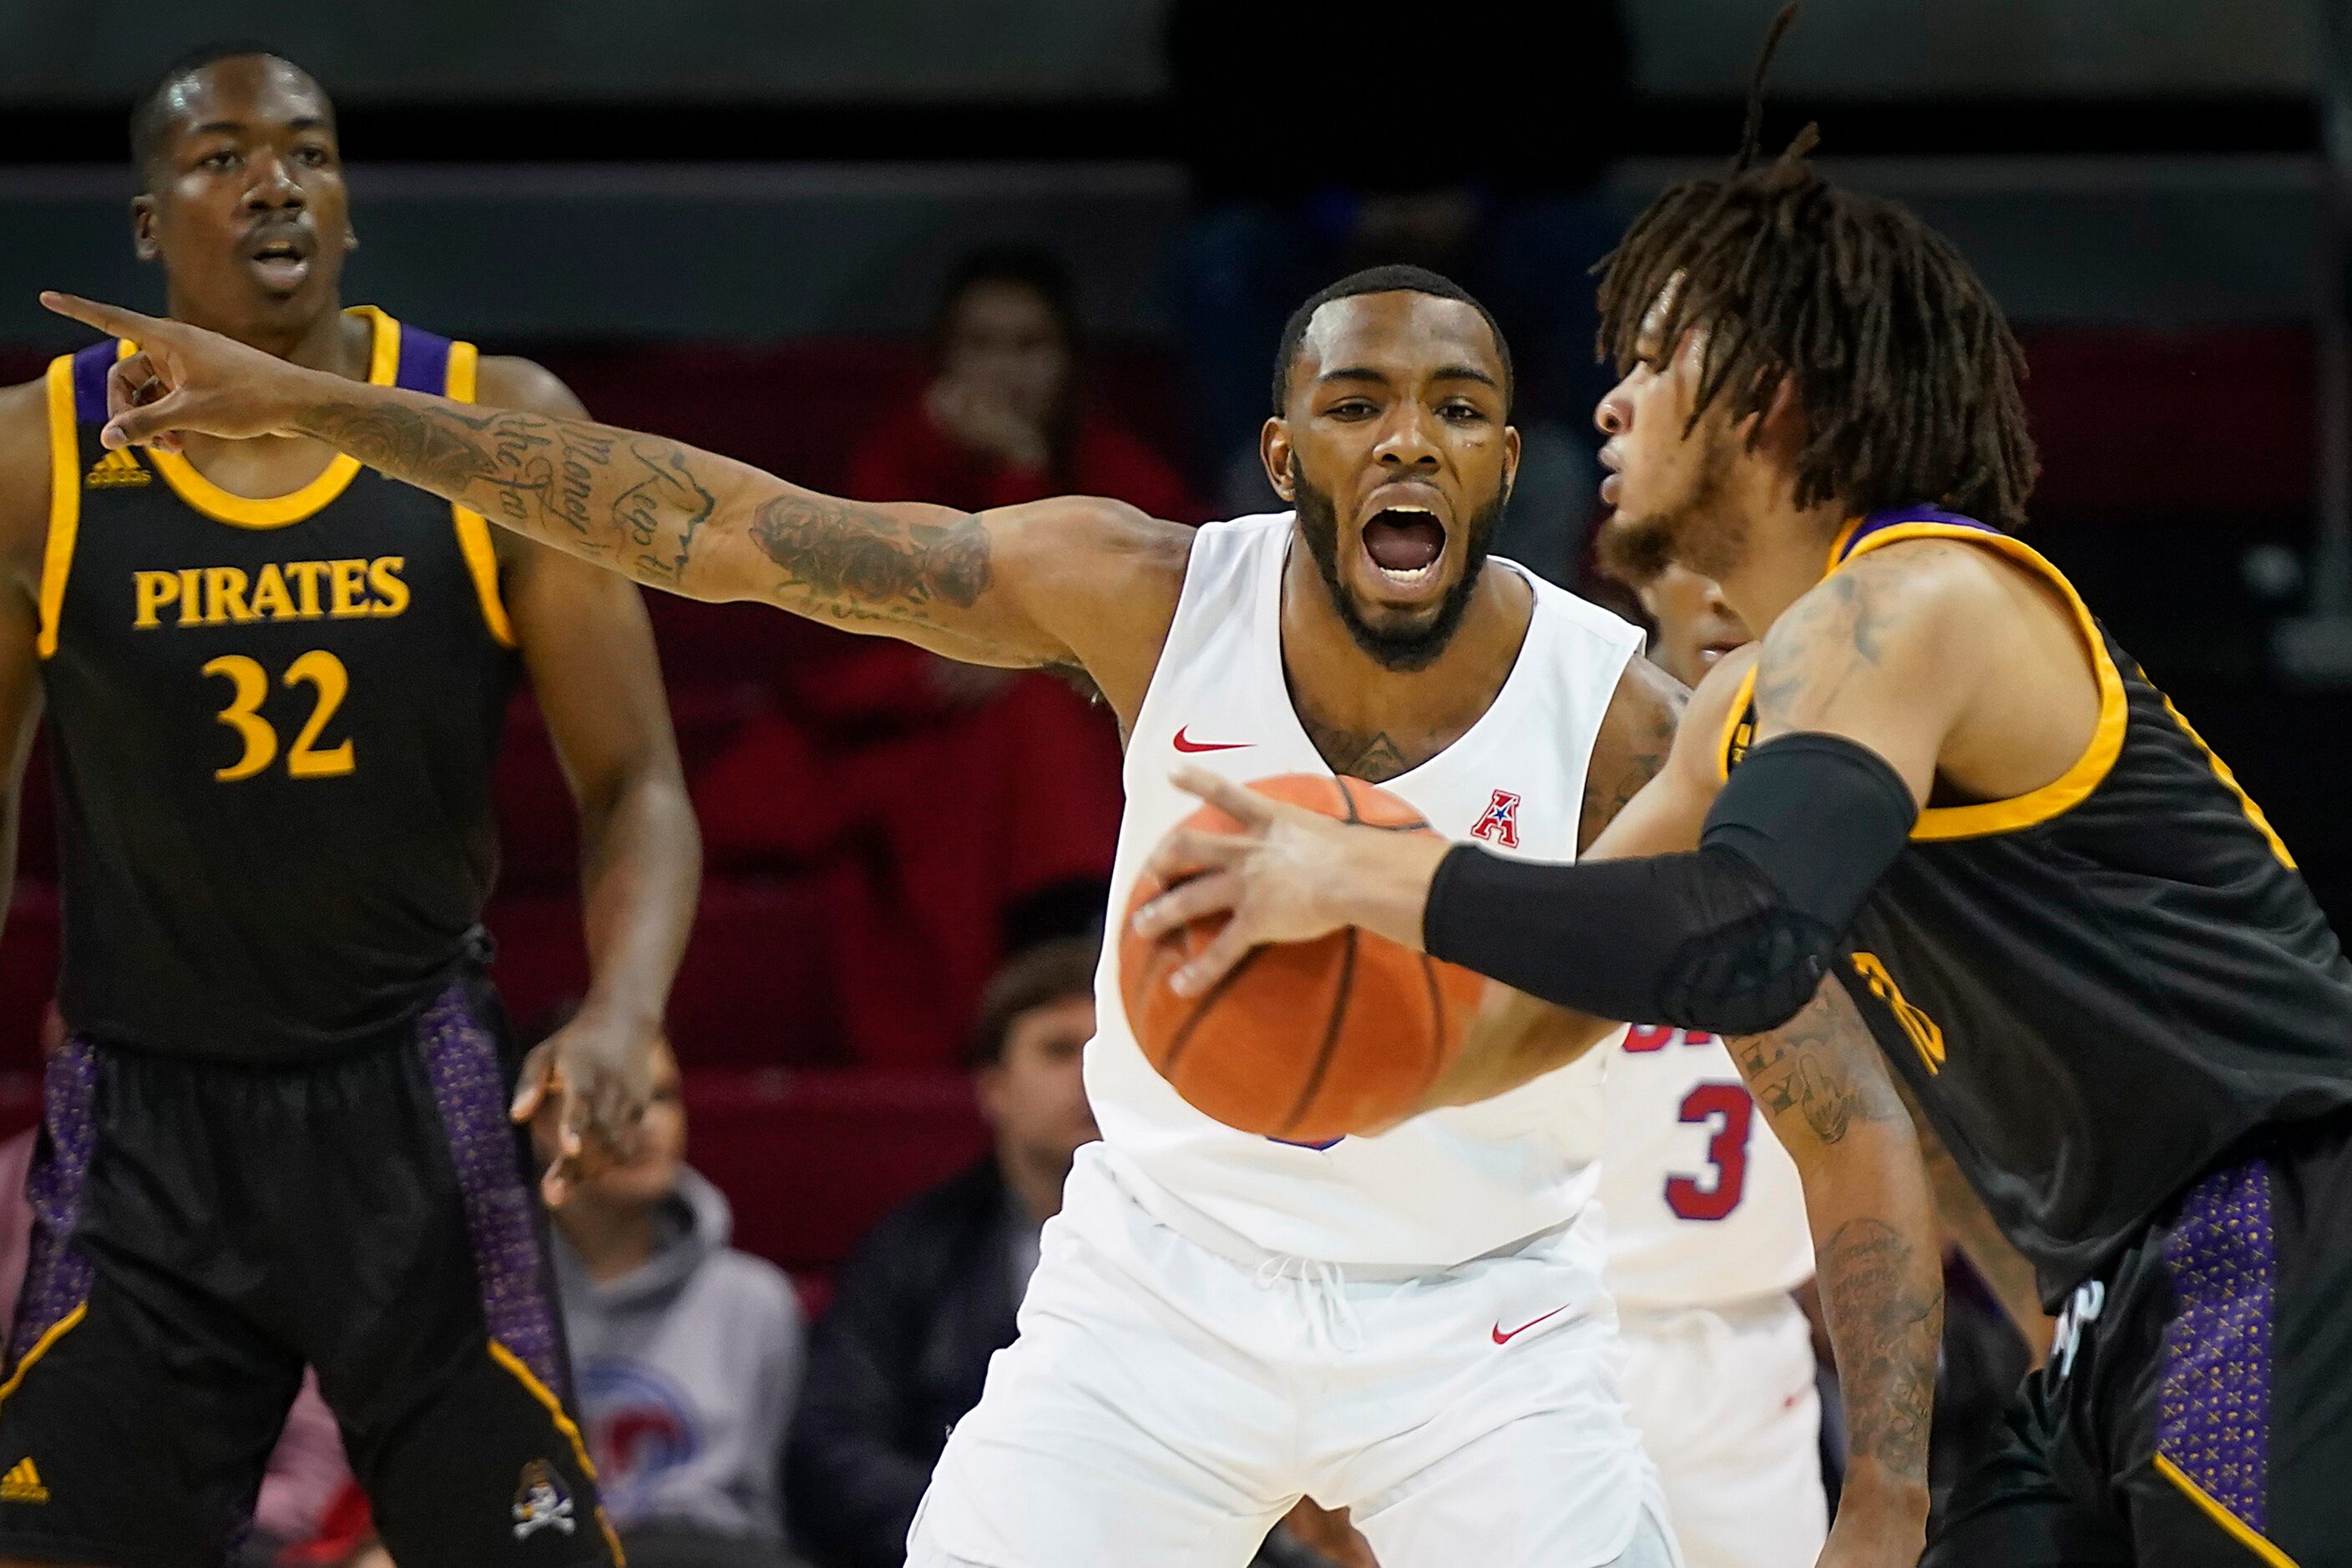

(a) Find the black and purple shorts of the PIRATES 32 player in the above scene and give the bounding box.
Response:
[0,980,621,1568]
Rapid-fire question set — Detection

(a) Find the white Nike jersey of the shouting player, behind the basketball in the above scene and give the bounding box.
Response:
[1086,513,1641,1269]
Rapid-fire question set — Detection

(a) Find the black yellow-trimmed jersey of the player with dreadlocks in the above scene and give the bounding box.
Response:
[1724,508,2352,1305]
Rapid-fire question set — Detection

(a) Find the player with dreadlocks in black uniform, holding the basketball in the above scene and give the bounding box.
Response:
[1119,12,2352,1568]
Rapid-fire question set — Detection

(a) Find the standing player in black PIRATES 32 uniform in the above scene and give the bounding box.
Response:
[0,49,699,1568]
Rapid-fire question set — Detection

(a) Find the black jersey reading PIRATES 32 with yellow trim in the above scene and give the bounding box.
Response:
[40,308,518,1063]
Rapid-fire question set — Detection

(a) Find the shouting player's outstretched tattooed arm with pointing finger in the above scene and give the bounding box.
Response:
[43,294,1190,717]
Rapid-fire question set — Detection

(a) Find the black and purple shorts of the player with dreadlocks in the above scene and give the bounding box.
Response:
[1924,1119,2352,1568]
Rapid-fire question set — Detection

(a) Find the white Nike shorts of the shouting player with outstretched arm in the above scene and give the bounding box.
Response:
[908,1145,1675,1568]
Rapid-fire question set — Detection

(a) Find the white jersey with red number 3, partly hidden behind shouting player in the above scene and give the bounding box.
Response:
[1601,1027,1813,1307]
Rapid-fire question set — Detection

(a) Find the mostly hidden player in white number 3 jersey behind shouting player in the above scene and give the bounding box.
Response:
[1600,524,1830,1568]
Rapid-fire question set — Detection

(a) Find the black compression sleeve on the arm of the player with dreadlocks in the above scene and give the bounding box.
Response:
[1423,733,1920,1034]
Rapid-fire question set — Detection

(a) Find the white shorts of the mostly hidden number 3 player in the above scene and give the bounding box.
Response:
[1623,1295,1830,1568]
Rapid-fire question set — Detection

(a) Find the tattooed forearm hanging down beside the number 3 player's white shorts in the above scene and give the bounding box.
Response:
[1813,1216,1943,1485]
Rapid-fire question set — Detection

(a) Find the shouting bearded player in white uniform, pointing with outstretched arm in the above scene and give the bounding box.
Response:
[49,268,1938,1568]
